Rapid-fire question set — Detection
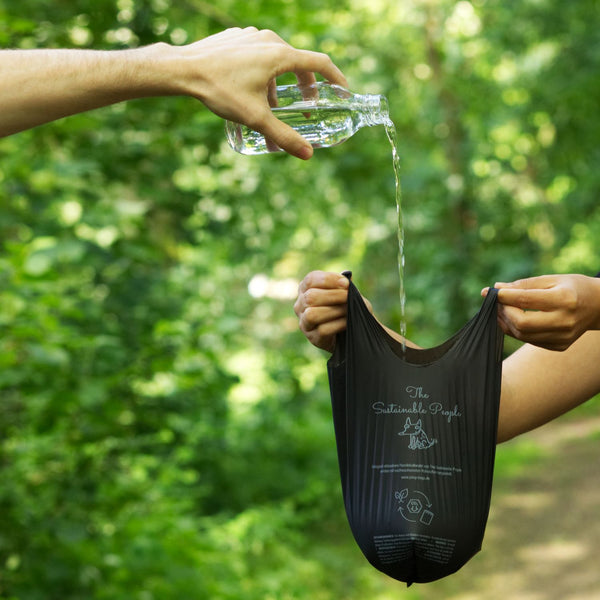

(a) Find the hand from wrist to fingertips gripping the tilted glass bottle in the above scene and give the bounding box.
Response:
[173,27,348,159]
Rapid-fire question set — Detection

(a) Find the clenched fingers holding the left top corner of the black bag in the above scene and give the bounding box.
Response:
[294,271,349,352]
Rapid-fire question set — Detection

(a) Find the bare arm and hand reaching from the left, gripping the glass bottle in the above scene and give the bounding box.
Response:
[0,27,347,158]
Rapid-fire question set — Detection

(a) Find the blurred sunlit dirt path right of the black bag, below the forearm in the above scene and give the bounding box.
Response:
[386,417,600,600]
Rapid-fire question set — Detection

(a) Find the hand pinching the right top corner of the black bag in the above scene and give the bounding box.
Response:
[481,275,600,350]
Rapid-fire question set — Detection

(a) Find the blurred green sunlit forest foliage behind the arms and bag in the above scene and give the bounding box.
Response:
[0,0,600,600]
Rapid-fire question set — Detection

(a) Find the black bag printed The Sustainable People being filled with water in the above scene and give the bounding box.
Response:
[328,274,503,585]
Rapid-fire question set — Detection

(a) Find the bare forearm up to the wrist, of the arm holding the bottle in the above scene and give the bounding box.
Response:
[0,44,176,136]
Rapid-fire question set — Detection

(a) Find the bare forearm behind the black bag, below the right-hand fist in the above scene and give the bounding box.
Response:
[498,331,600,442]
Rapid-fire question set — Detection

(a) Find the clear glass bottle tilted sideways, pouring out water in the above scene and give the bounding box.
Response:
[225,81,390,154]
